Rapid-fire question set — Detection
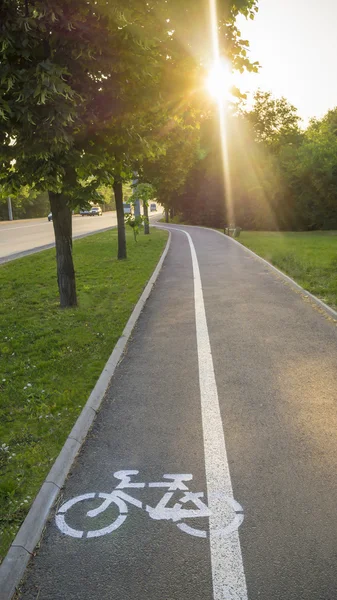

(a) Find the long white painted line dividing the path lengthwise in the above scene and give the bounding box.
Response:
[179,230,248,600]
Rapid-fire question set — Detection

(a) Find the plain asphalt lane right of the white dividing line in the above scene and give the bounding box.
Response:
[182,229,337,600]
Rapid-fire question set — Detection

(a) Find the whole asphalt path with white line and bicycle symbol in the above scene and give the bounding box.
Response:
[20,227,337,600]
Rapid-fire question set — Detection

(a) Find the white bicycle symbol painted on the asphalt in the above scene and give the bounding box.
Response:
[56,470,243,538]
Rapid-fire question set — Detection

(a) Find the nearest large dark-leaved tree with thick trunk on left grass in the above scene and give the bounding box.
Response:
[0,0,172,306]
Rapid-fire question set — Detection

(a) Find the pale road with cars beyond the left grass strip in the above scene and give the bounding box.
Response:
[0,211,117,261]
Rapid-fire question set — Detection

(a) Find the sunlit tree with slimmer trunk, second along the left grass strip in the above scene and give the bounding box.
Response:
[96,0,256,251]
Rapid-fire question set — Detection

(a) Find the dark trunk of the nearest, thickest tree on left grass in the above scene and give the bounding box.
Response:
[49,192,77,308]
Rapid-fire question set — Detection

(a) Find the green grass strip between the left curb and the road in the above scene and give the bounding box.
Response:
[0,228,168,559]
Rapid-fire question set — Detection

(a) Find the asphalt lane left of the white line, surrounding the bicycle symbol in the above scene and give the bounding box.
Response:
[21,234,212,600]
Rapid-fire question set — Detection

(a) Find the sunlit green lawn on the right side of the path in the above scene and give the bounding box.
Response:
[238,231,337,308]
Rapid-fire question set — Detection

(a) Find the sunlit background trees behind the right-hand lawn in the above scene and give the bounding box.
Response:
[166,90,337,230]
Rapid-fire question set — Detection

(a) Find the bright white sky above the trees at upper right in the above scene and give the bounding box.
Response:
[235,0,337,124]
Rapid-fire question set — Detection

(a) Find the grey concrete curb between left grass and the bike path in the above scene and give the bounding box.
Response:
[0,232,171,600]
